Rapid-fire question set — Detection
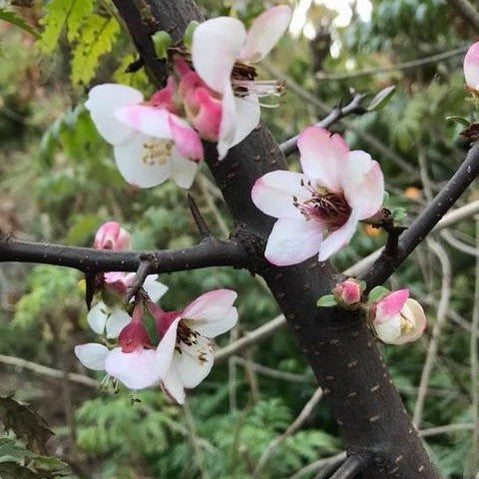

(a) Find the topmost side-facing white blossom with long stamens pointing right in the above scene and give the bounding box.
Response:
[191,5,291,159]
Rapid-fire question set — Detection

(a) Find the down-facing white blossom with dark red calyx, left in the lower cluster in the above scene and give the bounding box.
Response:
[75,304,169,390]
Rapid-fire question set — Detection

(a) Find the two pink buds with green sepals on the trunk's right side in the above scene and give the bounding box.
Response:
[318,278,426,344]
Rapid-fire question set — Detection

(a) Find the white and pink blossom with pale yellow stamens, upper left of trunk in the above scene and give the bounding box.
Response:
[85,81,203,188]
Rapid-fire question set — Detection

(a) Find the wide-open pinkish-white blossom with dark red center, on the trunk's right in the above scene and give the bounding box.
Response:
[251,126,384,266]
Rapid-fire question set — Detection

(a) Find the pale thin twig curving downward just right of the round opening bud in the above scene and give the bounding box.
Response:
[413,240,451,427]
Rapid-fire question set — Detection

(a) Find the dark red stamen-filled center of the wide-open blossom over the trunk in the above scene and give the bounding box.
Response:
[293,183,351,231]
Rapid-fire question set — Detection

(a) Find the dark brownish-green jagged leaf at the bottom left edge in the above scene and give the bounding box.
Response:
[0,397,53,456]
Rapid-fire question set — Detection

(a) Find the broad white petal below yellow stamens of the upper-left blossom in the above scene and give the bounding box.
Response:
[115,133,171,188]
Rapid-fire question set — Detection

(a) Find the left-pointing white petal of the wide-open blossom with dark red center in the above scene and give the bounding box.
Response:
[251,170,311,218]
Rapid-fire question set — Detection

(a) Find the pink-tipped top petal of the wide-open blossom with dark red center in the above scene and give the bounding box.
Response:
[298,126,349,191]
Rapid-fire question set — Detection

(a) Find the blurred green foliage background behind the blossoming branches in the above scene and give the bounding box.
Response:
[0,0,479,479]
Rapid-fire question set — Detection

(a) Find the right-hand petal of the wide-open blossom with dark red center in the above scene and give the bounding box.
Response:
[340,150,384,220]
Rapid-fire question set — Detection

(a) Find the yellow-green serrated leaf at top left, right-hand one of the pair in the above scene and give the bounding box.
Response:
[71,13,120,85]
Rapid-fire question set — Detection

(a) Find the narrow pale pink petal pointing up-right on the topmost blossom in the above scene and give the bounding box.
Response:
[240,5,292,62]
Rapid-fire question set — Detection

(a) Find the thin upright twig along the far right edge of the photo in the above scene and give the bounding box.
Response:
[470,216,479,452]
